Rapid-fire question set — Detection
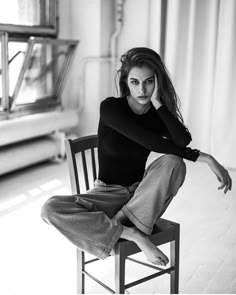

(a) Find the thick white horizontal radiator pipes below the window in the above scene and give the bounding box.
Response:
[0,110,78,175]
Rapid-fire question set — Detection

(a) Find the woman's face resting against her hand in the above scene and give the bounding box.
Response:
[127,66,155,105]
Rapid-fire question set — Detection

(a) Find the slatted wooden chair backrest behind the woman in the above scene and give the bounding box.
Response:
[65,135,98,194]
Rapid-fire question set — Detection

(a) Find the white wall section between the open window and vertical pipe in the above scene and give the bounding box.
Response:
[59,0,114,135]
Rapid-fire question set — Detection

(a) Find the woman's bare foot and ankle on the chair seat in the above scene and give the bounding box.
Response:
[121,226,169,266]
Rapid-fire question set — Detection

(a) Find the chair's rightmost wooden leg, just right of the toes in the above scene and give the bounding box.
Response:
[170,225,180,294]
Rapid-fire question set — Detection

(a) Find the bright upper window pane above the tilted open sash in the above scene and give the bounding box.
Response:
[0,0,55,26]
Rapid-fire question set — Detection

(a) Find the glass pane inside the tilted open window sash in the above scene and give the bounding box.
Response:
[10,39,77,107]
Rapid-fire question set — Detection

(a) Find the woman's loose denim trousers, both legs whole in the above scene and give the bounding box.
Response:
[41,155,186,259]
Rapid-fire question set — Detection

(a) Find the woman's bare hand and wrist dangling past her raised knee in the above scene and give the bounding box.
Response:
[197,152,232,193]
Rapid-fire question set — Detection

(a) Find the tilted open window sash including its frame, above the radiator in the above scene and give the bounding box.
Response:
[9,38,77,111]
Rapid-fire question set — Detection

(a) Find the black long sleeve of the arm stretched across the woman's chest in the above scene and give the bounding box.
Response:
[100,98,198,161]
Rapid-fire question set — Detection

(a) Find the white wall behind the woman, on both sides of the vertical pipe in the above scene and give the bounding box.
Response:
[59,0,160,135]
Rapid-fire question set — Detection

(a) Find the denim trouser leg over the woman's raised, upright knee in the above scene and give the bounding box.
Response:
[122,155,186,235]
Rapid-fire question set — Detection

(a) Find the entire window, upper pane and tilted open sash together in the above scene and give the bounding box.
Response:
[0,0,78,119]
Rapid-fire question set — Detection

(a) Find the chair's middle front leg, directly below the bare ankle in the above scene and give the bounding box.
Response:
[115,245,125,294]
